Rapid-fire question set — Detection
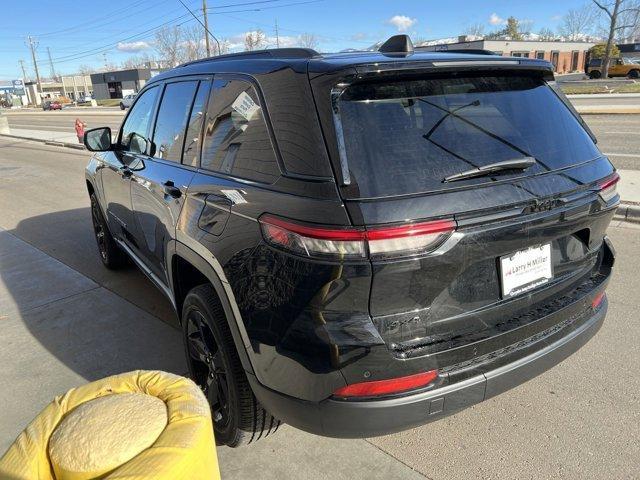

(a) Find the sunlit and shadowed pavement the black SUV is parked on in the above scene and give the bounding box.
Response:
[0,136,640,480]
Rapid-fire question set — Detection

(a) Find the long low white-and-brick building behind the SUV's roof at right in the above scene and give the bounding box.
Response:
[417,35,595,73]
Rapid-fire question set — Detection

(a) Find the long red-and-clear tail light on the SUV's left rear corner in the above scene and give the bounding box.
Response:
[260,215,456,259]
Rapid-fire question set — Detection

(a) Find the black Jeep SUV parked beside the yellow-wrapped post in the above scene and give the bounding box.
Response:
[85,36,619,446]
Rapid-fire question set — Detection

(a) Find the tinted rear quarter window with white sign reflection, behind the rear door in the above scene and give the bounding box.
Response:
[201,80,280,183]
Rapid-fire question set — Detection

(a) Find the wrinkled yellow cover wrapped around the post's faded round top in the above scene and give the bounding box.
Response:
[0,370,220,480]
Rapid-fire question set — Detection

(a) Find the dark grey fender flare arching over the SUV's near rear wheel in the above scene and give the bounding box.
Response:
[167,240,255,375]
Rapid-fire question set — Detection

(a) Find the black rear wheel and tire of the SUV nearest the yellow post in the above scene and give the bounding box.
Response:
[181,284,281,447]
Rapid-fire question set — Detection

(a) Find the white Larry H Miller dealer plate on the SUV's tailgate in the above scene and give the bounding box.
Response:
[500,243,553,297]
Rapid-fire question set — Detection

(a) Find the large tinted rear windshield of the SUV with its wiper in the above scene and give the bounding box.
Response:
[336,75,600,198]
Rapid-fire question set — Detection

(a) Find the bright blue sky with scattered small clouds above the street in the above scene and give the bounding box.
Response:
[0,0,586,79]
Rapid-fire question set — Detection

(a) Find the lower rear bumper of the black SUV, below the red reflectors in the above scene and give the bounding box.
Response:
[249,298,608,438]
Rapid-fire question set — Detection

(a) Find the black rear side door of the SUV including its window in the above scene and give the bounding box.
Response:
[131,78,210,285]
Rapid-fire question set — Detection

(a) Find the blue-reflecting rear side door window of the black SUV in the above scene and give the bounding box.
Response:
[153,81,198,162]
